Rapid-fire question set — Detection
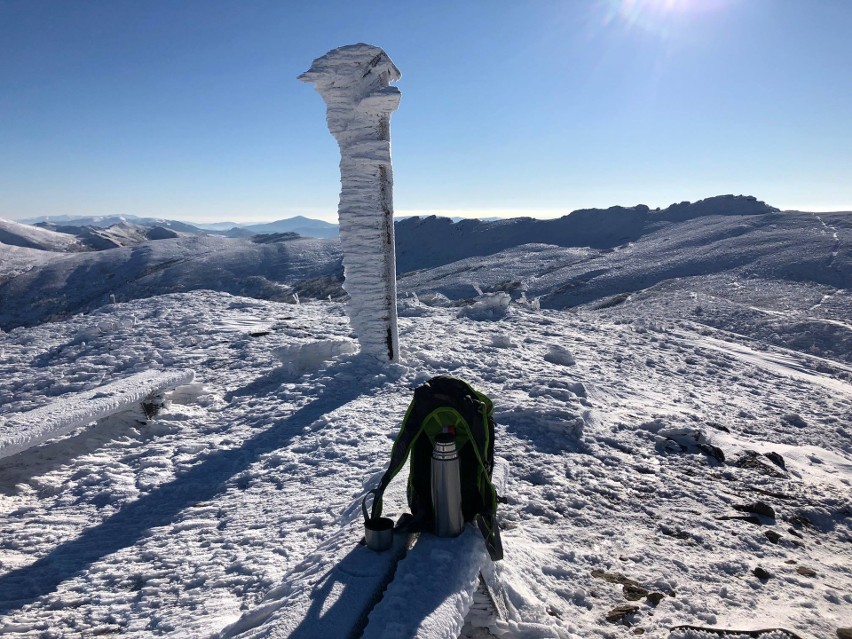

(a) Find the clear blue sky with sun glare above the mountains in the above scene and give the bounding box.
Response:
[0,0,852,221]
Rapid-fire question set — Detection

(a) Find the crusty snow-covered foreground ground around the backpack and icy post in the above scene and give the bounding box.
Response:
[0,292,852,639]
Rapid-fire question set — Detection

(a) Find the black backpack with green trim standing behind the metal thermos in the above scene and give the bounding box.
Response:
[370,375,503,561]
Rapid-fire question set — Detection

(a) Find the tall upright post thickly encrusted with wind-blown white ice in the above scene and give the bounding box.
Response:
[299,44,400,362]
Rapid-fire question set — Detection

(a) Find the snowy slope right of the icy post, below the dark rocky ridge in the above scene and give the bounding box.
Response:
[398,213,852,362]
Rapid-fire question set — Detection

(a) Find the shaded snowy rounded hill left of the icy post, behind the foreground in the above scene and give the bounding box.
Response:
[0,236,342,330]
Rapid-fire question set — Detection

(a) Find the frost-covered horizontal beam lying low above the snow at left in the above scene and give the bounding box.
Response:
[0,369,195,457]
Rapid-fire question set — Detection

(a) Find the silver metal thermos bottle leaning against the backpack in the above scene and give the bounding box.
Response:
[432,433,464,537]
